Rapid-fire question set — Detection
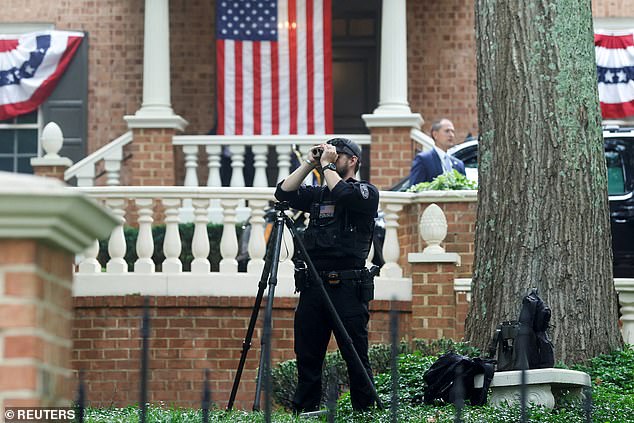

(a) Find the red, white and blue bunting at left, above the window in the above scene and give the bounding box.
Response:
[0,31,84,120]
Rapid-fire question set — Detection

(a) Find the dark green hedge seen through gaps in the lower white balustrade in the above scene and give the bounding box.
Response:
[97,223,246,271]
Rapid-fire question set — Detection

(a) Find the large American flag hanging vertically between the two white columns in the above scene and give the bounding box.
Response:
[216,0,333,135]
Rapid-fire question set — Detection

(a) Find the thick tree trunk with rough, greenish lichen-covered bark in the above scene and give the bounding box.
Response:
[466,0,622,363]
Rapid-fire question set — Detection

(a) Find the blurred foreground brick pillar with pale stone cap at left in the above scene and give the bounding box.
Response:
[0,172,116,414]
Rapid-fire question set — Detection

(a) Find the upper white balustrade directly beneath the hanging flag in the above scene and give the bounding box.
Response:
[173,134,370,187]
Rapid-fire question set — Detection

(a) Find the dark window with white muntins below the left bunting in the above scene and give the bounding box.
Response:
[0,111,40,173]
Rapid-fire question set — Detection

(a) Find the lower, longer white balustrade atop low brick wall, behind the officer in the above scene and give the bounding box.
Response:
[70,186,415,300]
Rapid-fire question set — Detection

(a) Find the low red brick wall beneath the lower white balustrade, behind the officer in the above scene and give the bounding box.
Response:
[72,292,410,409]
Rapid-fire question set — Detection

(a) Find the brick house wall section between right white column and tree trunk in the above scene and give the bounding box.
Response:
[407,0,478,140]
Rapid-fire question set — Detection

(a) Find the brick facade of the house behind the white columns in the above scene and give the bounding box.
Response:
[0,0,631,186]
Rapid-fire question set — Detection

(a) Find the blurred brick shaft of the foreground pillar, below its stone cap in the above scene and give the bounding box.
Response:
[0,239,73,408]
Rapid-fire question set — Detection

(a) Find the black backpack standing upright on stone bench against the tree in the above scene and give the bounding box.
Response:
[489,289,555,372]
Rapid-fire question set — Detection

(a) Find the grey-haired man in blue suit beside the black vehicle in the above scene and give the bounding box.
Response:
[409,118,465,185]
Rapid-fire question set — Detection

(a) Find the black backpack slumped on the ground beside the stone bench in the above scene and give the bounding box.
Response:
[423,352,494,405]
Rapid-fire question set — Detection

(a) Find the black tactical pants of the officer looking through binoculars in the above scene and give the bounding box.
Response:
[293,280,374,412]
